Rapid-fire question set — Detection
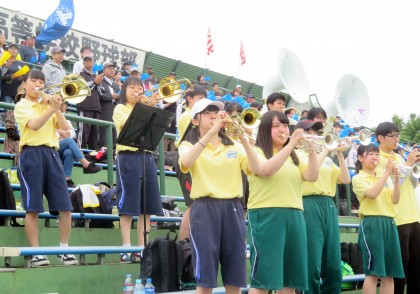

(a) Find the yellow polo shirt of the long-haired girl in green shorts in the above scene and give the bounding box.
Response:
[248,147,305,210]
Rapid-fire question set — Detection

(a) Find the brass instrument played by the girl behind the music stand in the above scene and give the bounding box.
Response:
[146,78,194,103]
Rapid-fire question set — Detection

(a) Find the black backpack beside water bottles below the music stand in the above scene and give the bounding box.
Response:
[139,230,183,293]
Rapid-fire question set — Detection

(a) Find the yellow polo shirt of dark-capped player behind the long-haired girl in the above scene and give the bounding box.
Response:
[296,150,340,197]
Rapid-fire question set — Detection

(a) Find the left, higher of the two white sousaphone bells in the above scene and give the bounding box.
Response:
[263,48,309,112]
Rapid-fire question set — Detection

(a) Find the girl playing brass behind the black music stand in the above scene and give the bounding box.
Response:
[112,76,162,263]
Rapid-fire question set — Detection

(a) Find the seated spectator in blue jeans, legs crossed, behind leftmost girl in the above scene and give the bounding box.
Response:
[57,101,101,188]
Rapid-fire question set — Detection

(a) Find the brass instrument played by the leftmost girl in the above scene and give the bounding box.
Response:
[35,74,91,104]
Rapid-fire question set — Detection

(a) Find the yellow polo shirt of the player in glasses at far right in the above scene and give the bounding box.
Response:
[379,150,420,226]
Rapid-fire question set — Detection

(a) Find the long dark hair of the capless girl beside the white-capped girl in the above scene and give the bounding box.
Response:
[255,111,299,165]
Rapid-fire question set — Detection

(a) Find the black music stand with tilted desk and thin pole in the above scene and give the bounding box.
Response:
[117,103,175,246]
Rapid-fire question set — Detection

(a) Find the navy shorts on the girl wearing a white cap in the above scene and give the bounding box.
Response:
[190,197,246,288]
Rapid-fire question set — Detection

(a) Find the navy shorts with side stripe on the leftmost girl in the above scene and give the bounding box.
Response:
[18,146,73,214]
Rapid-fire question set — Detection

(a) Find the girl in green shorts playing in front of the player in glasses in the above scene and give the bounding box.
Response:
[352,144,404,293]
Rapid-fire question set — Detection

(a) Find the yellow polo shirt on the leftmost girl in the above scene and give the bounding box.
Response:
[15,99,59,150]
